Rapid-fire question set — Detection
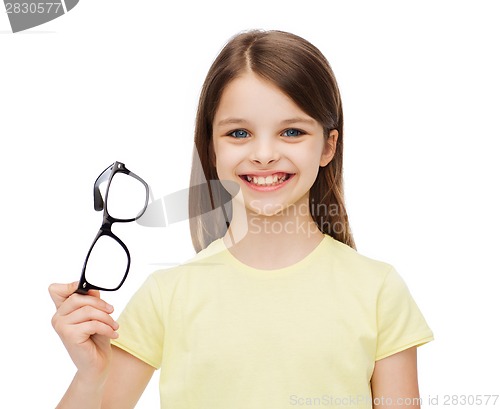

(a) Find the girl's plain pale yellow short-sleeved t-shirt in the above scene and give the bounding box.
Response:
[113,235,433,409]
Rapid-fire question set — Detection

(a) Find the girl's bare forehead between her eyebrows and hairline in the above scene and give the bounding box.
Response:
[214,72,316,126]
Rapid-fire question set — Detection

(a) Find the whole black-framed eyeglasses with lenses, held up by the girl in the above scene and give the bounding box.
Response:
[76,162,149,294]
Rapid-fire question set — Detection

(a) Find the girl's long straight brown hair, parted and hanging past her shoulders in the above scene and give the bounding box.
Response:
[189,30,355,251]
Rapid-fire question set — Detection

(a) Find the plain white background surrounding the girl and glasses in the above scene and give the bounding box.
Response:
[0,0,500,408]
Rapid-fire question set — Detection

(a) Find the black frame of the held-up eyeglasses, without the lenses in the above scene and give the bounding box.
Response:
[75,162,149,294]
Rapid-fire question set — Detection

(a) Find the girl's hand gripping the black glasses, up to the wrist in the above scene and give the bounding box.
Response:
[49,282,118,382]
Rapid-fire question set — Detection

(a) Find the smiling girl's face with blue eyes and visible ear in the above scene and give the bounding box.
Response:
[213,72,338,216]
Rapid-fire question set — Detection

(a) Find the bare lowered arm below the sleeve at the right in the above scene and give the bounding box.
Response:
[371,347,420,409]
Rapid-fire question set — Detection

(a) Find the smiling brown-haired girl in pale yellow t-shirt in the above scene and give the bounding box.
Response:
[50,31,432,409]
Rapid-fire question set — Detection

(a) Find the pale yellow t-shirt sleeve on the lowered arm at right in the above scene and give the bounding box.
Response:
[375,269,434,360]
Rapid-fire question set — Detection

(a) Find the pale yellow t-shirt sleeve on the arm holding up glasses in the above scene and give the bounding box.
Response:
[111,274,164,369]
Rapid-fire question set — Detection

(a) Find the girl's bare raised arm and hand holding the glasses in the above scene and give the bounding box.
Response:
[49,283,154,409]
